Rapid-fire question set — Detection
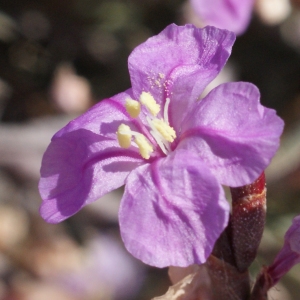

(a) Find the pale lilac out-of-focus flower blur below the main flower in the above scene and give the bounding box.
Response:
[58,235,144,299]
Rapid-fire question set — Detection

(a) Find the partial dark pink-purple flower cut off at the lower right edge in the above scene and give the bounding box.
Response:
[266,216,300,286]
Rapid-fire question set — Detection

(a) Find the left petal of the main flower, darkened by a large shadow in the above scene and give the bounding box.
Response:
[39,93,144,223]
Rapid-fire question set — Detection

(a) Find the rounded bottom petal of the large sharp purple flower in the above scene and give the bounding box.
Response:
[119,151,229,267]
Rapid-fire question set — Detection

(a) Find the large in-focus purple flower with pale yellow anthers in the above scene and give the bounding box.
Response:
[39,24,283,267]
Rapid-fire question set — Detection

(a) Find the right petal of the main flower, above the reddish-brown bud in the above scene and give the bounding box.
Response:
[178,82,284,187]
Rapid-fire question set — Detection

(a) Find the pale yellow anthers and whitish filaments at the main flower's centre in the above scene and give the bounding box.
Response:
[117,92,176,159]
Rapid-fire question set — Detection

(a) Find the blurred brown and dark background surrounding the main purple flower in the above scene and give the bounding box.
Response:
[0,0,300,300]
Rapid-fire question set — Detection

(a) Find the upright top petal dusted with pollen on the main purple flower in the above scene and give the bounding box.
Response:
[128,24,235,130]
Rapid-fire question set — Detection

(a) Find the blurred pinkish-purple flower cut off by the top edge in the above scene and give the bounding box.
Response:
[190,0,254,34]
